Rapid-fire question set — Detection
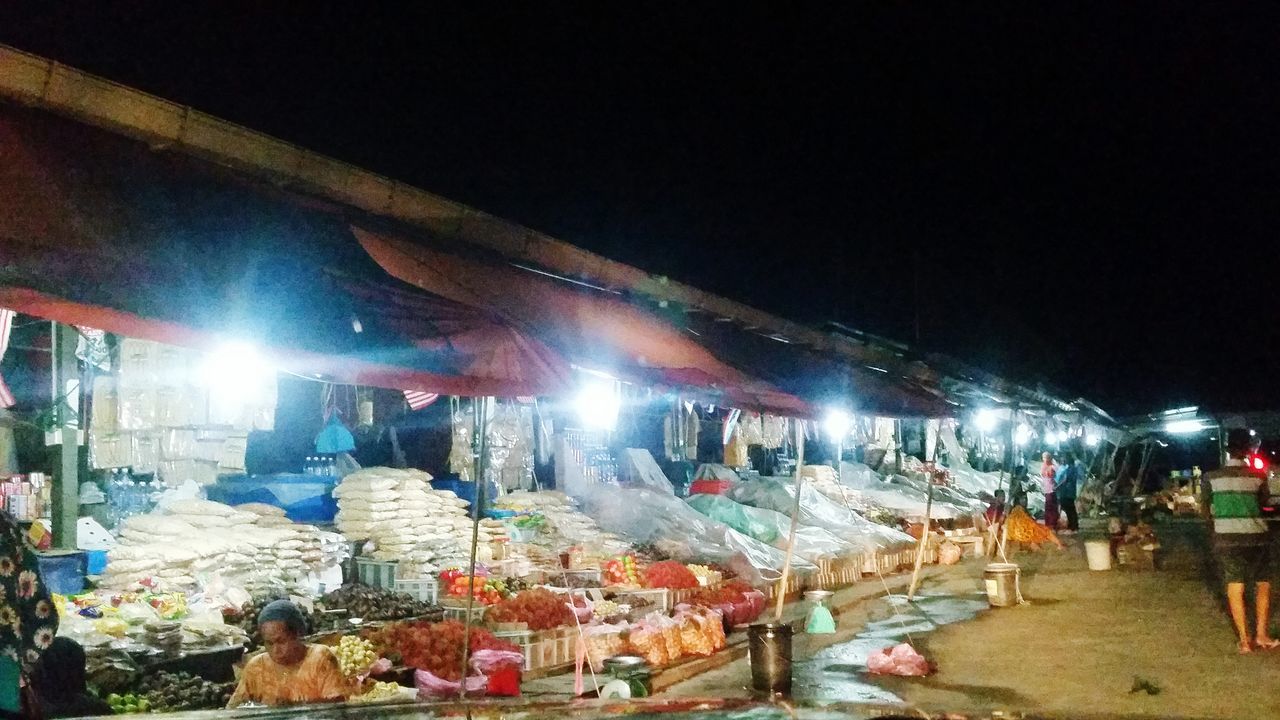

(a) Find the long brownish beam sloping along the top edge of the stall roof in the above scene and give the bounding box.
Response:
[0,45,921,384]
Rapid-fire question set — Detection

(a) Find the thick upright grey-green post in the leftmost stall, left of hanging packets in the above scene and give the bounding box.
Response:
[52,323,79,550]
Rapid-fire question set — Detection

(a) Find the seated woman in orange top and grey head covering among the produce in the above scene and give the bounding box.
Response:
[227,600,352,707]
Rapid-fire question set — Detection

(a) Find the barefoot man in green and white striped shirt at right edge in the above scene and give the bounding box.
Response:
[1203,447,1280,655]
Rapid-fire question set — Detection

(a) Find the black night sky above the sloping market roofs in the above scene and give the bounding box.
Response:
[0,1,1280,413]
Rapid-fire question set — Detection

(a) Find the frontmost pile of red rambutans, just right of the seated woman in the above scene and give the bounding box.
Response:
[369,620,520,683]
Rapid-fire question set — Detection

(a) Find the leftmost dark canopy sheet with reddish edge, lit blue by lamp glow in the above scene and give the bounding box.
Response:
[0,105,570,396]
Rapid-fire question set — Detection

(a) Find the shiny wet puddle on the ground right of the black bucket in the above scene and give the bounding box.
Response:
[791,593,988,703]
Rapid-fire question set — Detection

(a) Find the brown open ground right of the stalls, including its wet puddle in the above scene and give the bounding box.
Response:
[668,521,1280,717]
